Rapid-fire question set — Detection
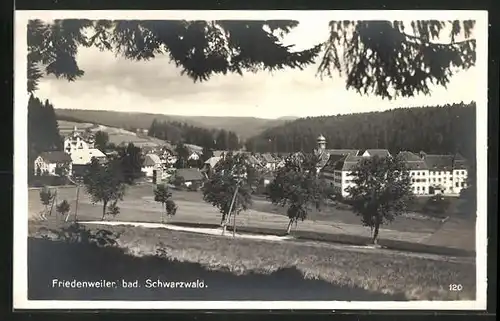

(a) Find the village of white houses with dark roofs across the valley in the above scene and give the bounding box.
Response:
[34,125,468,197]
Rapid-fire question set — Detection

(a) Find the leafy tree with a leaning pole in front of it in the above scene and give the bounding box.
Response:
[202,154,253,234]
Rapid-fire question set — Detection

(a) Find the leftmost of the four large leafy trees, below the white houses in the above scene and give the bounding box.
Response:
[83,158,126,220]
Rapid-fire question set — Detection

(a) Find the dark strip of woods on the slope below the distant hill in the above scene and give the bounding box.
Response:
[148,119,241,150]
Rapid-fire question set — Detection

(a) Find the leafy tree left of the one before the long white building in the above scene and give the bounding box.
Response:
[267,155,327,234]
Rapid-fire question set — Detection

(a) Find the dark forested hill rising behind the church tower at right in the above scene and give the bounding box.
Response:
[246,102,476,159]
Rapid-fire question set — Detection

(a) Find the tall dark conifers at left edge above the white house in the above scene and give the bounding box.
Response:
[28,95,63,177]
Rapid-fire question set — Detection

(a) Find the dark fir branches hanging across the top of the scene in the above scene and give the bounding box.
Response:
[27,19,476,98]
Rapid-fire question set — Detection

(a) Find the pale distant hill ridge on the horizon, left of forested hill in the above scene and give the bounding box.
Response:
[55,109,295,140]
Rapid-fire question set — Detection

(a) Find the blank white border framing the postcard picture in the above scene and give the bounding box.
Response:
[13,10,488,310]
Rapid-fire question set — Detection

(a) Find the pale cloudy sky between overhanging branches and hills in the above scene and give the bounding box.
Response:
[36,20,478,118]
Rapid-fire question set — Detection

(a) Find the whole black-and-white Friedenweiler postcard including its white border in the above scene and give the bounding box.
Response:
[13,11,488,310]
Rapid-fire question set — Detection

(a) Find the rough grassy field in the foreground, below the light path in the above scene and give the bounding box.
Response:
[29,222,475,300]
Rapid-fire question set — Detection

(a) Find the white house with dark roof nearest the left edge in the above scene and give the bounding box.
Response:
[34,151,73,176]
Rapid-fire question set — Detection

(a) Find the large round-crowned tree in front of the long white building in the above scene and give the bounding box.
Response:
[347,156,413,244]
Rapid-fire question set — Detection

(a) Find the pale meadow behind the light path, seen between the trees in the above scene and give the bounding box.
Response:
[28,185,475,252]
